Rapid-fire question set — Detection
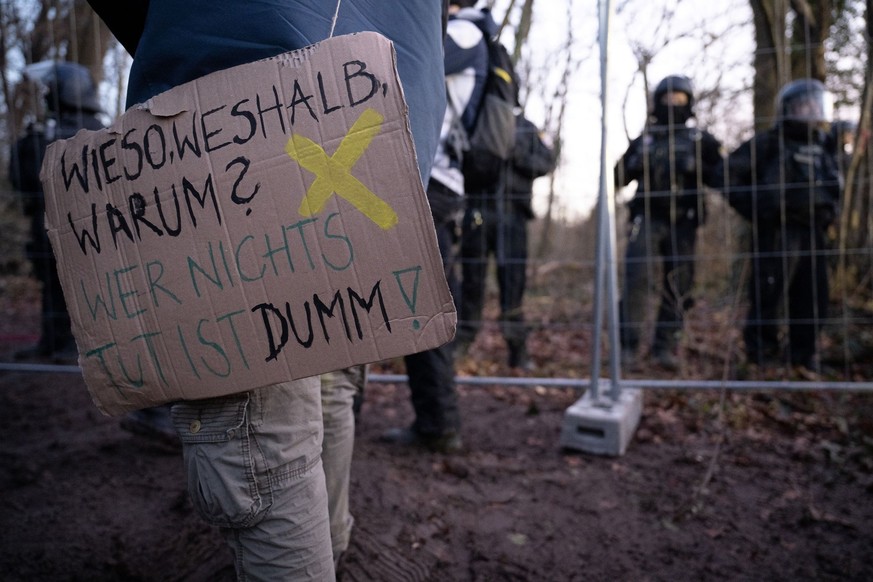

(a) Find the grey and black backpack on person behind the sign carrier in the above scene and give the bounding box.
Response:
[461,34,518,192]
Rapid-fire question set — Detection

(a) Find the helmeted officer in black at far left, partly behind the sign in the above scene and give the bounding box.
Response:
[9,61,103,361]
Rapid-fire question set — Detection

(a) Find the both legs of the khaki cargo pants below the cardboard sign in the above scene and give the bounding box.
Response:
[172,365,367,577]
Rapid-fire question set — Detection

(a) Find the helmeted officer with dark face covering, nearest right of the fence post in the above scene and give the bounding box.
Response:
[615,75,722,370]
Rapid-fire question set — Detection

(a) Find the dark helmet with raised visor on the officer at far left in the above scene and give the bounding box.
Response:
[25,61,102,115]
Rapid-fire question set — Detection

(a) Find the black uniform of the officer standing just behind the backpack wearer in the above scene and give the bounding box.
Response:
[458,115,555,366]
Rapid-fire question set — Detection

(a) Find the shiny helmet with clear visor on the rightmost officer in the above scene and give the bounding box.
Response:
[776,79,834,131]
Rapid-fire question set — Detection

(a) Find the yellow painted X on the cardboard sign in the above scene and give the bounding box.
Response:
[285,109,397,230]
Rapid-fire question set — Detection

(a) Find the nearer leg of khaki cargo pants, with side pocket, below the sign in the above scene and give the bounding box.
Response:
[171,377,335,581]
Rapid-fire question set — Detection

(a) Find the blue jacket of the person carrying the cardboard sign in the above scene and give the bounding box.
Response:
[89,0,445,182]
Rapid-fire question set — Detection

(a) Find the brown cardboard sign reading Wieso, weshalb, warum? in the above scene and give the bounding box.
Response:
[41,33,456,415]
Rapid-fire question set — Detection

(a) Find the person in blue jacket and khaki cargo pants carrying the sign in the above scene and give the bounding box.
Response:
[89,0,446,581]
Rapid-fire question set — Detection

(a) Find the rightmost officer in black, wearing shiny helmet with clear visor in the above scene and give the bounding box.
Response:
[725,79,842,369]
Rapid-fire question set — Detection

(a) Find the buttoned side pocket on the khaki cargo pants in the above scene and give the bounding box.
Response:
[172,394,272,528]
